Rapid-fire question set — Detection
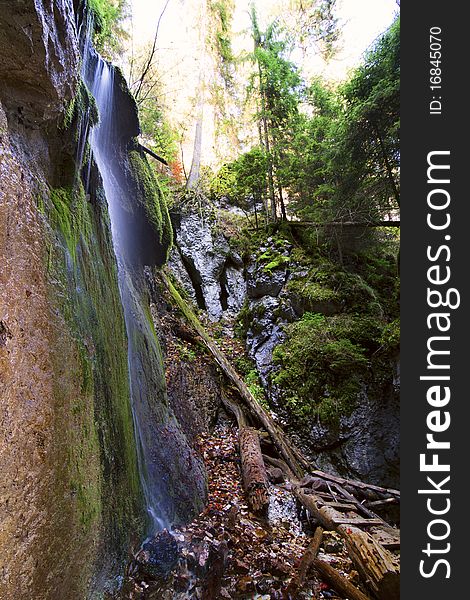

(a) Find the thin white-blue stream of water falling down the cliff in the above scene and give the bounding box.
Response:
[79,22,169,533]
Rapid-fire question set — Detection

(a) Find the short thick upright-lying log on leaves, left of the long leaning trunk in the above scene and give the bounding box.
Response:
[238,427,269,514]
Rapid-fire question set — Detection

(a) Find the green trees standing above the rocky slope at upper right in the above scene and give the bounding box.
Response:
[214,18,400,223]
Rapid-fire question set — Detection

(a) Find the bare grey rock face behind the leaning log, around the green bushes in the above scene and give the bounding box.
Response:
[170,212,399,487]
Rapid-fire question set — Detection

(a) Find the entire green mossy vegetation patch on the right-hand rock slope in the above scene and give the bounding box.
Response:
[273,241,398,424]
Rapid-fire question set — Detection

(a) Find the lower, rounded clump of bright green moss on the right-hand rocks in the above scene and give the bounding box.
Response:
[273,304,399,425]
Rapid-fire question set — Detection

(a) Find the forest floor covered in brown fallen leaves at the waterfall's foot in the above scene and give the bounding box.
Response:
[114,412,359,600]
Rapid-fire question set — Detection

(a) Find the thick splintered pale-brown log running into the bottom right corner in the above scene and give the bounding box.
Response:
[294,488,400,600]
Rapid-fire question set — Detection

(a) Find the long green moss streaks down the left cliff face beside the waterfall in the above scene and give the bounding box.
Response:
[46,173,144,568]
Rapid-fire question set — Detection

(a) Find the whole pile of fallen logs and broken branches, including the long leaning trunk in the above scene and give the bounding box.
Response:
[161,273,400,600]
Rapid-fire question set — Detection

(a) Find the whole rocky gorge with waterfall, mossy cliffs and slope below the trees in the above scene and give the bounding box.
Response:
[0,0,399,600]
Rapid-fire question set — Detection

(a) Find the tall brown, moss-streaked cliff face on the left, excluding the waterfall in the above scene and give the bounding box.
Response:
[0,0,205,600]
